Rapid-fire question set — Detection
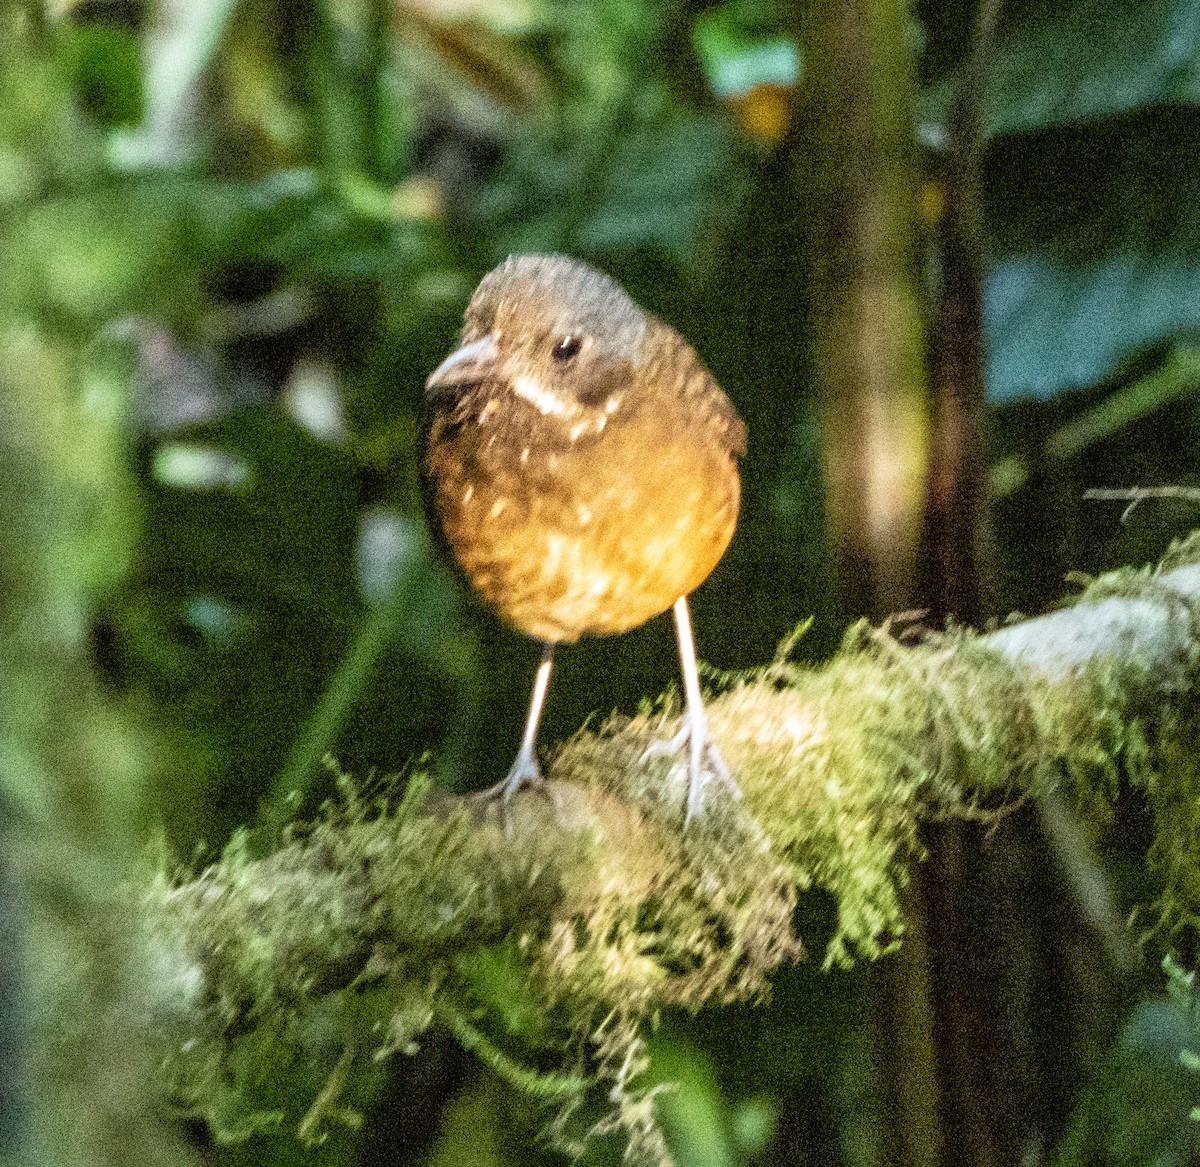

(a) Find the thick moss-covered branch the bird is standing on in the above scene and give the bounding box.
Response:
[145,538,1200,1159]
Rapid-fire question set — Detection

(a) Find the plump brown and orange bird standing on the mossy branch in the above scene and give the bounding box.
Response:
[421,256,745,822]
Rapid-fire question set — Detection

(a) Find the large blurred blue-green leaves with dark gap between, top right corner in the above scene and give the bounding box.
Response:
[969,0,1200,402]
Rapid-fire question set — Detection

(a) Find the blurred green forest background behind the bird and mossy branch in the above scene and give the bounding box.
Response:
[7,0,1200,1167]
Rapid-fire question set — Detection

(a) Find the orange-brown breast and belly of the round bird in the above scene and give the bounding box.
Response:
[426,398,739,642]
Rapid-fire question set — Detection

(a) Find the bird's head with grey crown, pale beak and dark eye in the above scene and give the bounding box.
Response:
[425,256,649,420]
